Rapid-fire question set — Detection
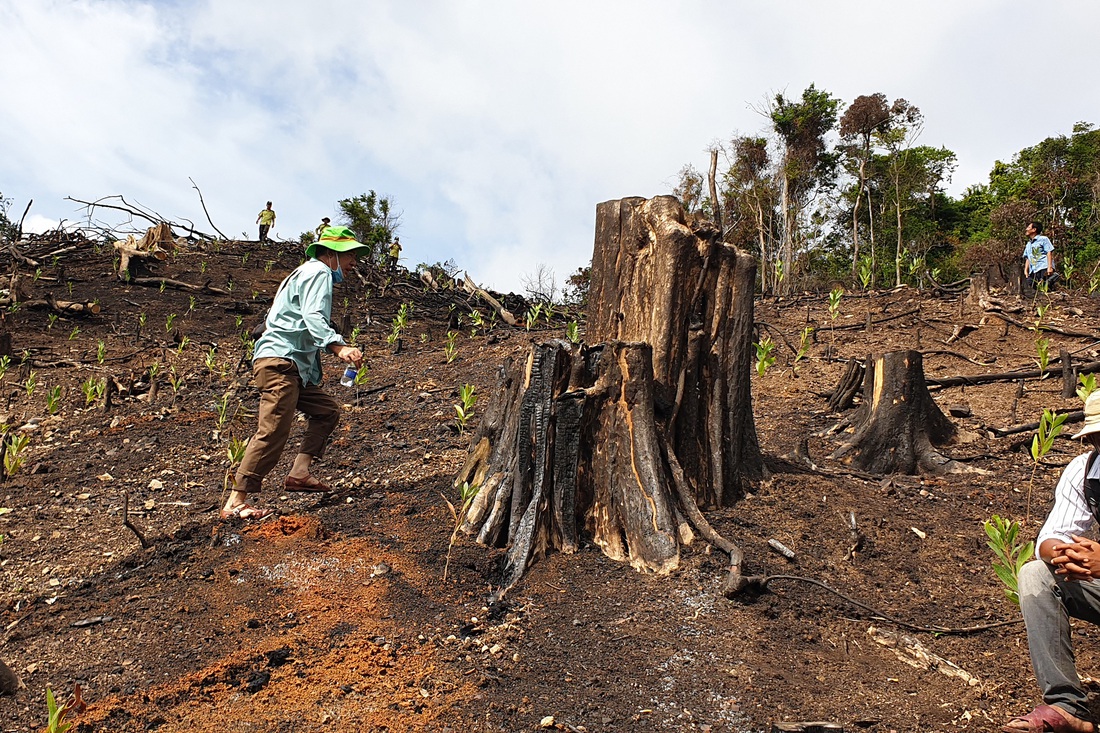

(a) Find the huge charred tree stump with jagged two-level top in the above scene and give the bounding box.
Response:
[455,196,763,593]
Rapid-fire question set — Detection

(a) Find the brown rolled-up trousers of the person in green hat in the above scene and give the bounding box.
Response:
[234,358,340,494]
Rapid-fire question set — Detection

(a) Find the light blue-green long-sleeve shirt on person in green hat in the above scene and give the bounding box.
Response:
[252,260,344,385]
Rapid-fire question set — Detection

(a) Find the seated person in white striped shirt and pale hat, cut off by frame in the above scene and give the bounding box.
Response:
[1003,391,1100,733]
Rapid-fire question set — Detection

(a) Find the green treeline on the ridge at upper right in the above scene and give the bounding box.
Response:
[673,85,1100,293]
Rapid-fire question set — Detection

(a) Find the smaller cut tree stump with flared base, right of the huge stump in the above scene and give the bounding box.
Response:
[833,351,969,474]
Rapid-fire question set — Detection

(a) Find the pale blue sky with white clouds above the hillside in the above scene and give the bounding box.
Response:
[0,0,1100,291]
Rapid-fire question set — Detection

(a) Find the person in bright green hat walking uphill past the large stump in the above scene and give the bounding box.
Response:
[221,227,369,519]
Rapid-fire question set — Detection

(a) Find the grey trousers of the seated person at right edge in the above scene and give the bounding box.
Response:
[1020,560,1100,720]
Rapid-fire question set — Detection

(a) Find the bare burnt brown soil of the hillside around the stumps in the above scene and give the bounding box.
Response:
[0,242,1100,733]
